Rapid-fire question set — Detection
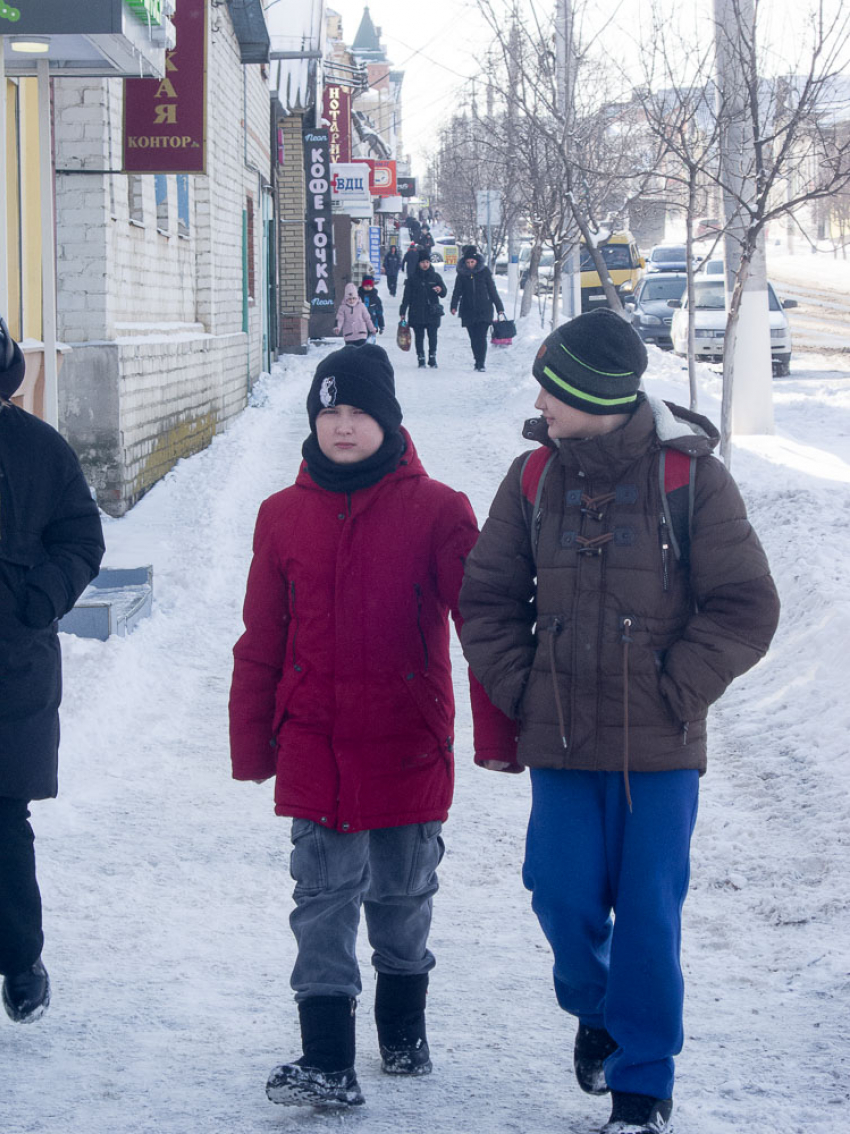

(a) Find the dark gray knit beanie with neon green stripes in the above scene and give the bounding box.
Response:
[532,307,647,414]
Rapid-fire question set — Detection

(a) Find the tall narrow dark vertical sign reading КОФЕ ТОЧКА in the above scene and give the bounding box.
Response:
[301,126,337,339]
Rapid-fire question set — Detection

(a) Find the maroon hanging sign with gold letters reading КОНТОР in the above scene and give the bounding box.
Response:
[124,0,206,174]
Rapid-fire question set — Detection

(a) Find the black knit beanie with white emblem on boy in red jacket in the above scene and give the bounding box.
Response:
[307,342,401,433]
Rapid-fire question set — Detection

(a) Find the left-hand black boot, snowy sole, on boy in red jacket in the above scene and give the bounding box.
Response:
[265,996,364,1107]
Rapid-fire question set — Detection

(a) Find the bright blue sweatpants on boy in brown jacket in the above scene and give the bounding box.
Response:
[522,769,699,1099]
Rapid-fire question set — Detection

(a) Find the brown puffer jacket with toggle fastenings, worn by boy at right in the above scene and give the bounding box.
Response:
[460,395,779,782]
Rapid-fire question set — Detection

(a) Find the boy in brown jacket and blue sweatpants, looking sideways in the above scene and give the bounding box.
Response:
[460,311,779,1134]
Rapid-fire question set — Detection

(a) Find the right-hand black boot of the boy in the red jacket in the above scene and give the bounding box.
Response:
[375,973,432,1075]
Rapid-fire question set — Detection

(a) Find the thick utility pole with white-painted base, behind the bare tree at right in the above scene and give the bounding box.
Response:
[714,0,773,433]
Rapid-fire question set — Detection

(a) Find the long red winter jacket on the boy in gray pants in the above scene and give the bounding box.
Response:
[230,432,516,831]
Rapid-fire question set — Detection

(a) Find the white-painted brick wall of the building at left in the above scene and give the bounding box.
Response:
[54,6,270,514]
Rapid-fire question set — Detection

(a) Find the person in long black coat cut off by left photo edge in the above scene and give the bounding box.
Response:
[0,319,104,1022]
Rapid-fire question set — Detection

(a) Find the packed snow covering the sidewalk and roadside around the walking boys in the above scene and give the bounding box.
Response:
[0,280,850,1134]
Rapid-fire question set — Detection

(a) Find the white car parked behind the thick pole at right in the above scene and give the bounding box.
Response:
[668,276,797,378]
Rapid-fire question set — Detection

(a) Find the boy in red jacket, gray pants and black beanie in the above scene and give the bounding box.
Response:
[230,345,515,1107]
